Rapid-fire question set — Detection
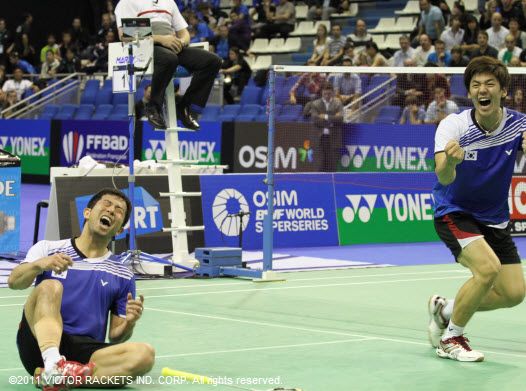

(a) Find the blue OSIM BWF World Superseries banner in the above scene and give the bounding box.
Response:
[201,174,338,249]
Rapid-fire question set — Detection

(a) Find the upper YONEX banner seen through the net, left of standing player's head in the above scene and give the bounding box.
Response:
[338,124,436,172]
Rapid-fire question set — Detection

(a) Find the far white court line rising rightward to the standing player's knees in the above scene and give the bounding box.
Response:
[143,276,466,299]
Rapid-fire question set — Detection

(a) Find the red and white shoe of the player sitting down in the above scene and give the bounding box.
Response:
[33,356,95,391]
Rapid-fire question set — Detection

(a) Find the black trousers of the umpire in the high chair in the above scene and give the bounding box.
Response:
[152,45,222,107]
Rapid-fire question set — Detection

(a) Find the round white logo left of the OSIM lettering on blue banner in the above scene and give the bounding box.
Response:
[212,189,250,236]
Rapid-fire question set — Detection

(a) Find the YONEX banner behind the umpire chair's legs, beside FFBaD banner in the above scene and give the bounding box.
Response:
[141,121,221,165]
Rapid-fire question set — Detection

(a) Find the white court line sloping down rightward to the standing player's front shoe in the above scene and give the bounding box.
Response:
[146,307,526,359]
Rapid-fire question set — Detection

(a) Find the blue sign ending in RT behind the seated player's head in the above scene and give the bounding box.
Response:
[75,187,163,240]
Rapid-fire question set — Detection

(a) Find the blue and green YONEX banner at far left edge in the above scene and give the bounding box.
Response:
[0,119,51,175]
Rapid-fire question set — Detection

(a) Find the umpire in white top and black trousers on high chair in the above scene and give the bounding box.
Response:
[115,0,221,130]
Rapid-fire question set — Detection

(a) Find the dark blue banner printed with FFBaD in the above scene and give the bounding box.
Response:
[60,120,129,166]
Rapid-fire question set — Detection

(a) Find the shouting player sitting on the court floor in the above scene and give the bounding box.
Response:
[8,189,155,391]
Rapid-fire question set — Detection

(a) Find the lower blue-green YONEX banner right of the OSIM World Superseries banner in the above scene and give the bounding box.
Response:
[334,173,438,245]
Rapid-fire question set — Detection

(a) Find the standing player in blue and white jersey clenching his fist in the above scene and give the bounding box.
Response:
[428,56,526,361]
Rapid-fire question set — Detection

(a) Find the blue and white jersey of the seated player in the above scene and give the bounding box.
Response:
[23,239,135,341]
